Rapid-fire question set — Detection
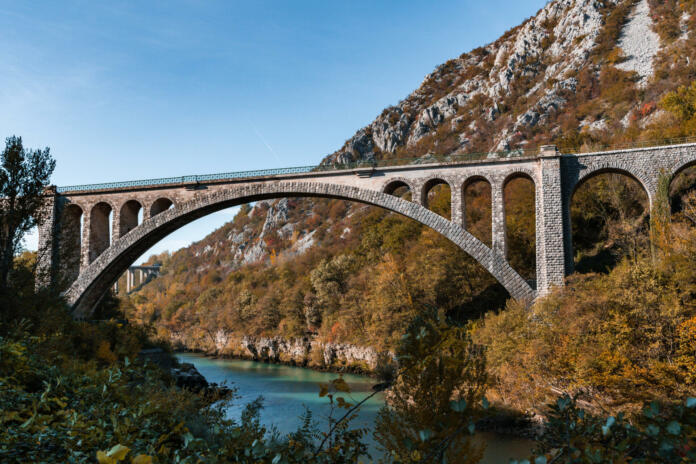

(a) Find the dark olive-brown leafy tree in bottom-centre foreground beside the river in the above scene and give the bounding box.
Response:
[375,310,486,463]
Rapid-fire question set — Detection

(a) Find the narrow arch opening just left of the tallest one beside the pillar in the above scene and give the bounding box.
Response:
[462,177,493,247]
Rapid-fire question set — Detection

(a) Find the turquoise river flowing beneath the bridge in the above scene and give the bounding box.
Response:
[177,353,532,464]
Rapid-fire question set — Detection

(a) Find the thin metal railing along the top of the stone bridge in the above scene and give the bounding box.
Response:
[57,137,696,193]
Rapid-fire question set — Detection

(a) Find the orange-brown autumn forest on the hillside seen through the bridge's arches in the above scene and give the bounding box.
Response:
[123,80,696,356]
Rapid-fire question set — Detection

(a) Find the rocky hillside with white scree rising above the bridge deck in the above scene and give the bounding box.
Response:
[330,0,694,162]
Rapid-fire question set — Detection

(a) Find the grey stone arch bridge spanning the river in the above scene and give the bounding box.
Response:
[39,144,696,317]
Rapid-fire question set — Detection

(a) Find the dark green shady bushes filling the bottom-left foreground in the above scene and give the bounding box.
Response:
[0,314,366,464]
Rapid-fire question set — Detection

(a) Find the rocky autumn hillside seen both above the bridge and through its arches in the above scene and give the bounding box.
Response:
[126,0,696,358]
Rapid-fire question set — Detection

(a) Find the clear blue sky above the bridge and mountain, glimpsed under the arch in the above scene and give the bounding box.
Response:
[0,0,545,260]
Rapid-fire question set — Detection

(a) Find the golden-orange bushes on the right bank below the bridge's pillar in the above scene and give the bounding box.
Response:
[474,219,696,414]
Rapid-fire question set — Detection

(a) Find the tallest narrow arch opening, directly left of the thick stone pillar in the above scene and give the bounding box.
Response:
[503,173,536,279]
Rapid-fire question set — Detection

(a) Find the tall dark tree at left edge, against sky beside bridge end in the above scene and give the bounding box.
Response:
[0,136,56,293]
